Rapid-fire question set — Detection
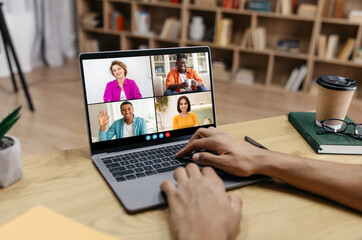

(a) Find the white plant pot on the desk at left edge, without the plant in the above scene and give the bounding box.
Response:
[0,136,23,188]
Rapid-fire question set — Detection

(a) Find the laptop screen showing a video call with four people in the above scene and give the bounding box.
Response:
[79,47,216,153]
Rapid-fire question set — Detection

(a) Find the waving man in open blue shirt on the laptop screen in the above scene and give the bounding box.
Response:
[98,102,148,141]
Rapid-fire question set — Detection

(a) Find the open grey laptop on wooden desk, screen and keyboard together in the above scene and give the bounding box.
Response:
[79,47,266,213]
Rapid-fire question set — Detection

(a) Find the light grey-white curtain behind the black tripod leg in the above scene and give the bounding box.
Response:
[0,0,77,77]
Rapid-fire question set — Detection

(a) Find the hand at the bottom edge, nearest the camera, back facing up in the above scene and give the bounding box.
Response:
[160,163,241,240]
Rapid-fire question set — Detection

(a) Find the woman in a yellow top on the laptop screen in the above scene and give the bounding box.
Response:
[173,96,200,130]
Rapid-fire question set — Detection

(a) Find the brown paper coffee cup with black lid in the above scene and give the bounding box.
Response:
[316,75,357,127]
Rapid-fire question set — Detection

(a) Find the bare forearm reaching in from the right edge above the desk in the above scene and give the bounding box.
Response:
[259,152,362,211]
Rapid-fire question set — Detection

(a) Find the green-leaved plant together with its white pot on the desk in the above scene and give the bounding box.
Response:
[0,106,23,188]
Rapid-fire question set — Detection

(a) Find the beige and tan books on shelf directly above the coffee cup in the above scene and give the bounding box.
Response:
[317,34,355,60]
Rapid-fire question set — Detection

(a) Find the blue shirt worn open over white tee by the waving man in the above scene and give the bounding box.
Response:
[99,115,148,141]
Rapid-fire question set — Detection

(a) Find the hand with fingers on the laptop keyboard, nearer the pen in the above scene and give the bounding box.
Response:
[176,127,272,177]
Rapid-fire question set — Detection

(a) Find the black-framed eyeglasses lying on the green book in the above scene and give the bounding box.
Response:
[317,119,362,140]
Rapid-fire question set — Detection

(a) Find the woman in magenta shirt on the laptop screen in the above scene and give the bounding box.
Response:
[103,61,142,102]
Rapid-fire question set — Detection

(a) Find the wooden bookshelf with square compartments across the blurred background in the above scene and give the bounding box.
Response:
[77,0,362,99]
